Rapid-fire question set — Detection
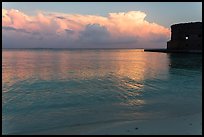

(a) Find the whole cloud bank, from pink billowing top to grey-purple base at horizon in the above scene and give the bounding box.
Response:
[2,9,170,48]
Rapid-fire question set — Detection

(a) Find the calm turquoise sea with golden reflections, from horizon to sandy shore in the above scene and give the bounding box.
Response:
[2,49,202,134]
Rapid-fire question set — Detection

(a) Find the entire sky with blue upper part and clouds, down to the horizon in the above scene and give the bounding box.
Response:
[2,2,202,48]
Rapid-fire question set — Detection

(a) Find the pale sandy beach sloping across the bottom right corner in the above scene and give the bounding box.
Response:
[28,113,202,135]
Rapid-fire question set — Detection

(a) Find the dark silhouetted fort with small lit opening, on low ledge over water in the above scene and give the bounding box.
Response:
[145,22,202,53]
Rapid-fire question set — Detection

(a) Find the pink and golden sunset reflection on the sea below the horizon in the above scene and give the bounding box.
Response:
[2,50,169,94]
